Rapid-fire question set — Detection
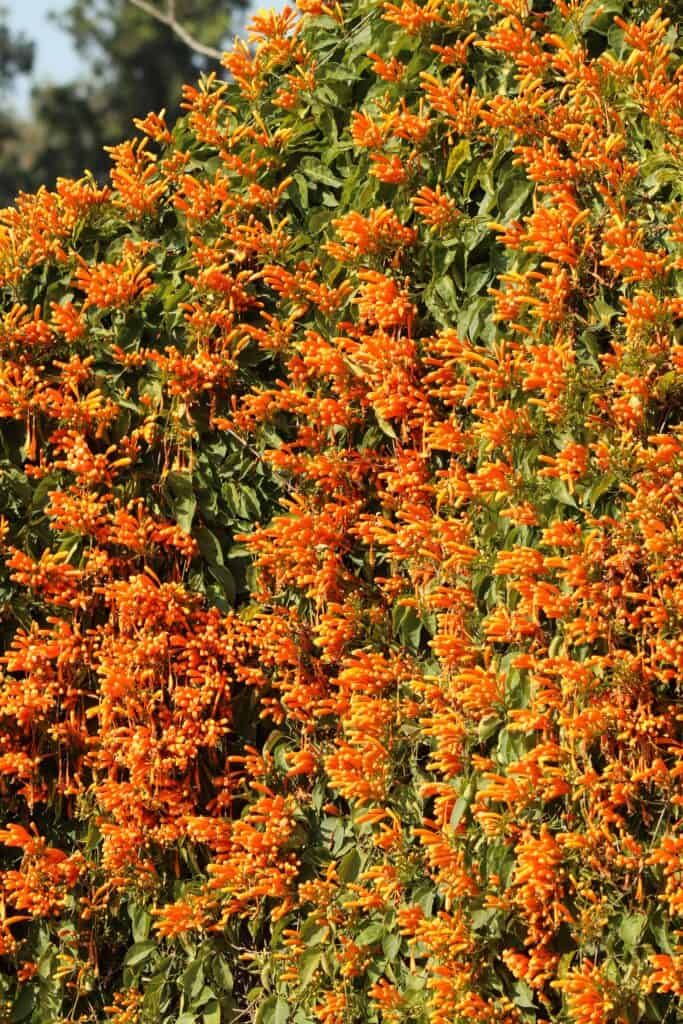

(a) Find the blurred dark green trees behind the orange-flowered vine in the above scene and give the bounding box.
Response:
[0,0,244,205]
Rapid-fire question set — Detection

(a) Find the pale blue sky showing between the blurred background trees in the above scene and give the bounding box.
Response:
[4,0,260,112]
